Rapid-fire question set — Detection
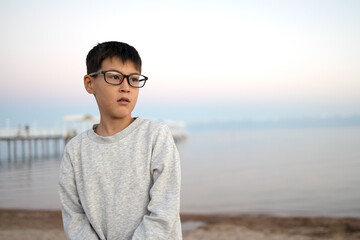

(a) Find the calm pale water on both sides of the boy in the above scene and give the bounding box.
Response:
[0,127,360,217]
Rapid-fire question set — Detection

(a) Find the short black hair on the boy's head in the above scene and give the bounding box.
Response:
[86,41,141,74]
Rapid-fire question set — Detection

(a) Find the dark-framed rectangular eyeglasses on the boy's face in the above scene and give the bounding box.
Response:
[89,70,148,88]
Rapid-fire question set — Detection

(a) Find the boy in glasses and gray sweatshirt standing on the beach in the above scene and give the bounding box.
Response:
[59,42,181,240]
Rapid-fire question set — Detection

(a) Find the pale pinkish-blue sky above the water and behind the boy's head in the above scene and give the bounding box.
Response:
[0,0,360,127]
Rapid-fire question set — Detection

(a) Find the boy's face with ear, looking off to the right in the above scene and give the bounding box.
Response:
[84,57,140,123]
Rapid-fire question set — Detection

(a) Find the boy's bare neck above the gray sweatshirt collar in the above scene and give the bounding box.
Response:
[95,116,134,137]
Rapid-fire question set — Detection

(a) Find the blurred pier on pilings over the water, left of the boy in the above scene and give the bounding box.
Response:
[0,135,73,161]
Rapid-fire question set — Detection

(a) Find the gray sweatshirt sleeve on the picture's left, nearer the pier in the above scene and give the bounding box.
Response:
[59,150,99,240]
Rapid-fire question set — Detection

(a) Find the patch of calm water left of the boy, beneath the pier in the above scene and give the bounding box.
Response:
[0,158,60,209]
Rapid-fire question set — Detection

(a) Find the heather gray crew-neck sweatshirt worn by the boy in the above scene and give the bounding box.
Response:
[59,118,182,240]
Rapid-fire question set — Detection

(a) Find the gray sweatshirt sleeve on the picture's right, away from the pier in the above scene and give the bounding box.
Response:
[132,126,182,240]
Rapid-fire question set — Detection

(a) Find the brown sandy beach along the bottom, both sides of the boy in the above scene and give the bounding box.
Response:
[0,209,360,240]
